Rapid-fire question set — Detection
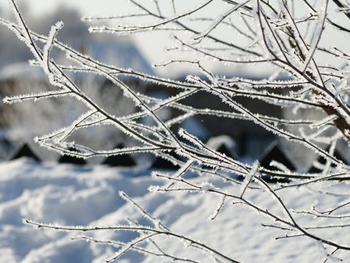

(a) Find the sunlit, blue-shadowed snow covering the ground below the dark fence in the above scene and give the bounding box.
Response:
[0,158,350,263]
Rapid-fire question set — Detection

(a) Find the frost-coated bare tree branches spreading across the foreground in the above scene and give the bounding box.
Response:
[0,0,350,262]
